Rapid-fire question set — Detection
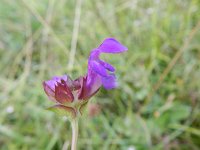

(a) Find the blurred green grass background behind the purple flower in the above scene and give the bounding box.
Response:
[0,0,200,150]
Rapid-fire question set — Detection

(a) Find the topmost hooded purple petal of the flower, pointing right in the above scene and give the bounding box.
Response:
[98,38,128,53]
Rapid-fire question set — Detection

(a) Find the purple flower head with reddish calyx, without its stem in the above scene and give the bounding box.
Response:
[43,38,128,116]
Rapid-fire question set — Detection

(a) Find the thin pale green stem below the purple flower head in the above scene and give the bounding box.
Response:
[71,118,78,150]
